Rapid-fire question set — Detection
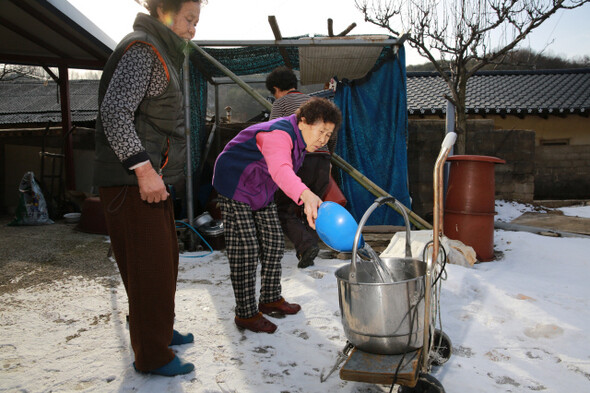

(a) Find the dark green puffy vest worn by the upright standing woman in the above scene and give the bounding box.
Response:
[94,13,186,187]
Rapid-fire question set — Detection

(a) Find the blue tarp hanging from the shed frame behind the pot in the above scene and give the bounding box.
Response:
[334,46,410,225]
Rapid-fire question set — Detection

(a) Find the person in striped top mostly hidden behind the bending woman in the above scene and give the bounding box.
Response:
[266,66,336,269]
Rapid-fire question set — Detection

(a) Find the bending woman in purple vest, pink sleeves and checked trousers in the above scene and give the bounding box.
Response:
[213,98,341,333]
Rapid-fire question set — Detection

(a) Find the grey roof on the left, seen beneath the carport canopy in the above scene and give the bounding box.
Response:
[0,77,98,125]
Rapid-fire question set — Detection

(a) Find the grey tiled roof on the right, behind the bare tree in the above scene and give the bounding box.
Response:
[407,68,590,116]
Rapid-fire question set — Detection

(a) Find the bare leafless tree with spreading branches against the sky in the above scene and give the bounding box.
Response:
[355,0,590,154]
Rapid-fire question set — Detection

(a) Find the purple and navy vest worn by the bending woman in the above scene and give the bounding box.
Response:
[213,115,307,210]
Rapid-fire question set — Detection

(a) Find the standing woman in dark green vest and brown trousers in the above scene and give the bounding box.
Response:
[94,0,201,376]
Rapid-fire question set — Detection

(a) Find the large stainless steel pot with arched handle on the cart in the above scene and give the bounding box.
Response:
[336,197,427,355]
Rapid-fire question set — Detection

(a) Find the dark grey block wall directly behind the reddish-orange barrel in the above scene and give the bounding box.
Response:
[408,119,535,220]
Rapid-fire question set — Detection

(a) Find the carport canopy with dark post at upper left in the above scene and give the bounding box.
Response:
[0,0,116,190]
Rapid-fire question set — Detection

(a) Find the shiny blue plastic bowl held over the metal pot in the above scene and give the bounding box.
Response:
[315,201,365,252]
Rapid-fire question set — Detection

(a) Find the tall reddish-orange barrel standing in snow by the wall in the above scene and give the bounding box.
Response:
[444,155,506,261]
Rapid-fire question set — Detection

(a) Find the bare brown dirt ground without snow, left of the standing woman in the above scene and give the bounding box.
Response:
[0,216,118,294]
